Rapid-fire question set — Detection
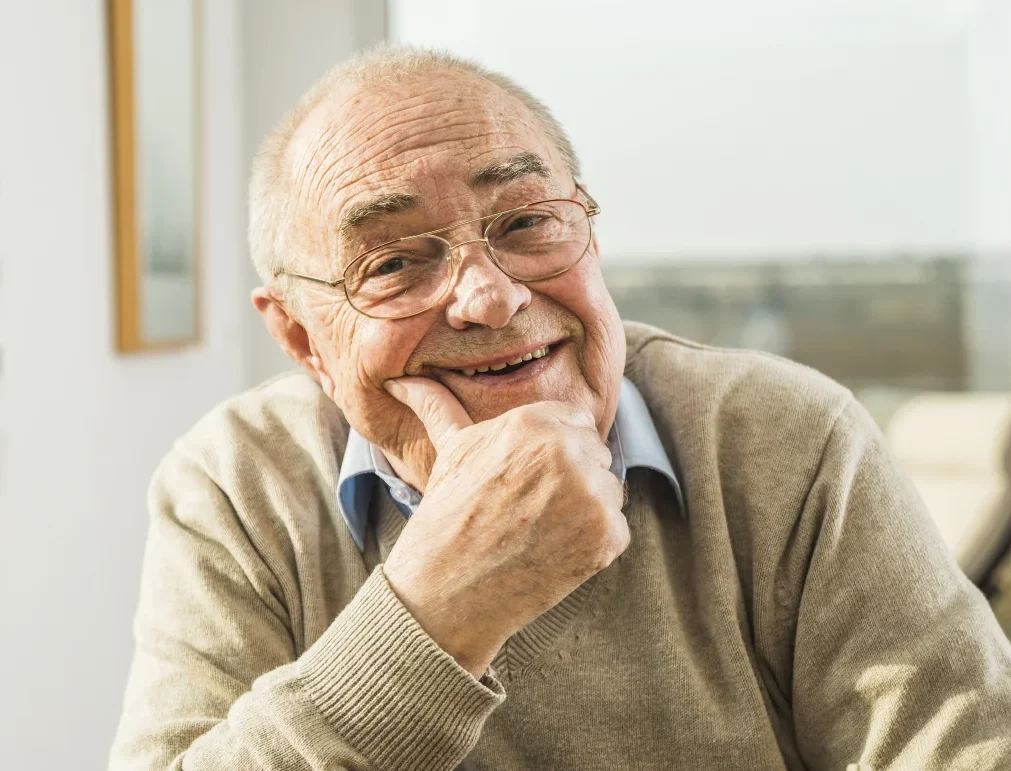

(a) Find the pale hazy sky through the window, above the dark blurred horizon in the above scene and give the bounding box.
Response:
[390,0,986,258]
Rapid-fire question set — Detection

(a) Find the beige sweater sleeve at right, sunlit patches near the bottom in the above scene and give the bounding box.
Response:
[793,401,1011,771]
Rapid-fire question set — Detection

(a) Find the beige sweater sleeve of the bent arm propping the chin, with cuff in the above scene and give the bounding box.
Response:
[109,451,504,771]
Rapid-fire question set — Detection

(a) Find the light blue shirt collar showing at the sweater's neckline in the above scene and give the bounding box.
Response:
[337,378,685,550]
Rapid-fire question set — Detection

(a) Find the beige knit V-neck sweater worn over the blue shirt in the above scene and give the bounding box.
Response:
[111,324,1011,771]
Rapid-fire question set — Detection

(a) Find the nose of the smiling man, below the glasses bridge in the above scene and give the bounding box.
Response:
[446,240,531,329]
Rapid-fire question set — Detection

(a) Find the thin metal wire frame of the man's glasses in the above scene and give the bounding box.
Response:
[274,183,601,321]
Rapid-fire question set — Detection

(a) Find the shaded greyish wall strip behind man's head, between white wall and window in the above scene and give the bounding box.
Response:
[243,0,385,383]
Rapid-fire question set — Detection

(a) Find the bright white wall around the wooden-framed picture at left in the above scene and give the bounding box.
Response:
[0,0,252,771]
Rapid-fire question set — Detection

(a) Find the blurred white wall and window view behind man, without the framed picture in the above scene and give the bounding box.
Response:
[0,0,1011,769]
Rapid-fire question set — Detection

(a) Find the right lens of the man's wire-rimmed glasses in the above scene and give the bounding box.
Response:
[487,201,590,281]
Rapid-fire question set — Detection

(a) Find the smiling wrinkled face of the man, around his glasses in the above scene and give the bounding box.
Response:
[277,73,625,477]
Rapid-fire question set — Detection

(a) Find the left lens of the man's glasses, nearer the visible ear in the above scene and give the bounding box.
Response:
[344,235,452,318]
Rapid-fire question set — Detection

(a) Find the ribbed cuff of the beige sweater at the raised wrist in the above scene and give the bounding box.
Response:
[300,566,506,771]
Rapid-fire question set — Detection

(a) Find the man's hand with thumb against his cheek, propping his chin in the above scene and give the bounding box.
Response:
[384,377,629,677]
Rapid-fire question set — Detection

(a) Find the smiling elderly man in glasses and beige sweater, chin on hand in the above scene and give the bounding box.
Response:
[112,50,1011,771]
